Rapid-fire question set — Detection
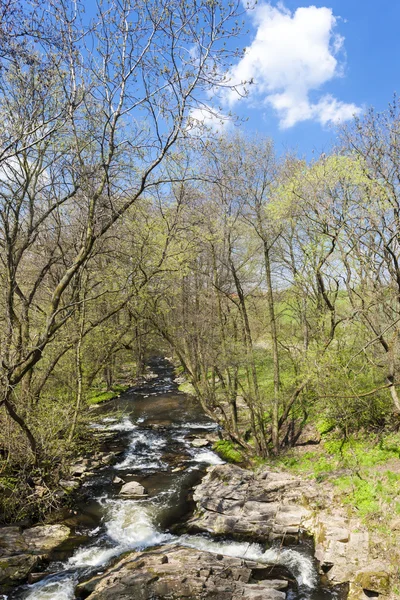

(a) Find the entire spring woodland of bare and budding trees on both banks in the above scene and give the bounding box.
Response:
[0,0,400,521]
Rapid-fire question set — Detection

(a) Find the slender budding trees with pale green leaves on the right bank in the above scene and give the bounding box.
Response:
[147,123,399,455]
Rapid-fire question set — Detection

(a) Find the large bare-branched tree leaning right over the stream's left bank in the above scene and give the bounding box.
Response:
[0,0,244,454]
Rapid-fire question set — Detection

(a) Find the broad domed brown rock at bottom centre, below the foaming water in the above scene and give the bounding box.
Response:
[79,546,287,600]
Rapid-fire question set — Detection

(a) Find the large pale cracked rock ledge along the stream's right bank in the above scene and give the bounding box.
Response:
[188,464,390,600]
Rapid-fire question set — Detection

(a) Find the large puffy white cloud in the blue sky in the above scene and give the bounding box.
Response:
[226,4,361,128]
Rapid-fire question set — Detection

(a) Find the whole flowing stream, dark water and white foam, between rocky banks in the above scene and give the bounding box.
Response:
[9,359,335,600]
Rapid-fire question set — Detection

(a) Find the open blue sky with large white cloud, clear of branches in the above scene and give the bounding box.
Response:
[209,0,400,158]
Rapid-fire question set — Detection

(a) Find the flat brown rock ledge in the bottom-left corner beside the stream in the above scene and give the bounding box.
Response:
[0,525,70,593]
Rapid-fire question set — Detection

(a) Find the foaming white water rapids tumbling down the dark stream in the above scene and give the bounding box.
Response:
[17,366,317,600]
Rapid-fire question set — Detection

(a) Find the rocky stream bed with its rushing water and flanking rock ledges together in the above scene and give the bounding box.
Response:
[0,360,390,600]
